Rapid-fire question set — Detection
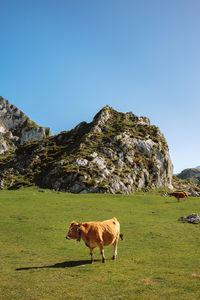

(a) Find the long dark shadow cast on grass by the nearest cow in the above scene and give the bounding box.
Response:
[15,260,99,271]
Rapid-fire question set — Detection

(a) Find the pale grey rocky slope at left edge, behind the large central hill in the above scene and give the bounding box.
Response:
[0,97,51,154]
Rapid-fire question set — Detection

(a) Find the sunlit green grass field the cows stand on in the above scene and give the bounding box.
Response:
[0,188,200,300]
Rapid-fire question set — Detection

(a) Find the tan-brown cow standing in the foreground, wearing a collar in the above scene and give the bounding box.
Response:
[66,218,123,263]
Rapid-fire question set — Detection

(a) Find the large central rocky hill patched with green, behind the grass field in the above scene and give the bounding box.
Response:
[0,106,173,194]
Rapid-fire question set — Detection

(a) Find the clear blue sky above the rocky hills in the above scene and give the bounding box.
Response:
[0,0,200,173]
